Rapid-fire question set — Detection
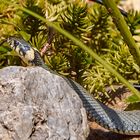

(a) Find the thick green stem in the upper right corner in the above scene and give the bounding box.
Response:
[103,0,140,66]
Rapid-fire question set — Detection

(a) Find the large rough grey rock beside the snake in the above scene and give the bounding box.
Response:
[0,66,89,140]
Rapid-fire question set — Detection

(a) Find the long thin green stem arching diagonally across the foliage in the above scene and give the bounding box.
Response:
[17,6,140,99]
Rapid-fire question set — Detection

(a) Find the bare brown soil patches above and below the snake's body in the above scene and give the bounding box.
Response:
[87,86,140,140]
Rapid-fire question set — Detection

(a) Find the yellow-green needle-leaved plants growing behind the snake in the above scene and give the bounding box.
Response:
[0,0,139,104]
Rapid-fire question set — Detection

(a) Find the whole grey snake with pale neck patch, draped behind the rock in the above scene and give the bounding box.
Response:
[4,37,140,135]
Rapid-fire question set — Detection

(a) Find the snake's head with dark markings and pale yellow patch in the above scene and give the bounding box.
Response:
[7,37,37,66]
